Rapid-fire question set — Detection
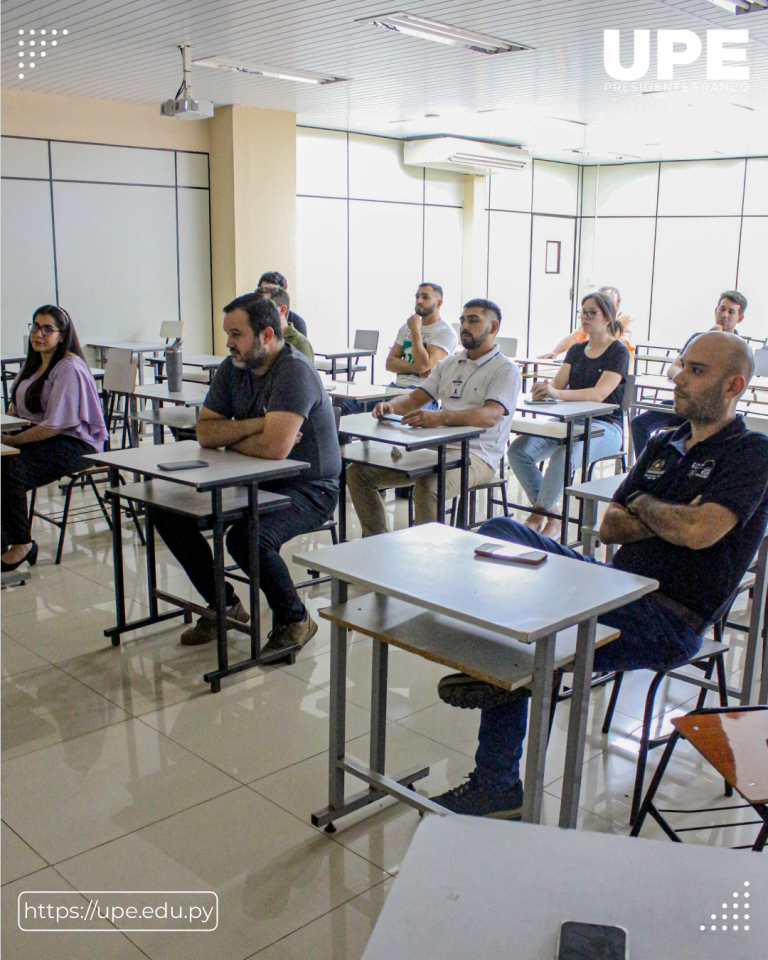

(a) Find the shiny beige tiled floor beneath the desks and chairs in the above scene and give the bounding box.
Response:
[2,468,754,960]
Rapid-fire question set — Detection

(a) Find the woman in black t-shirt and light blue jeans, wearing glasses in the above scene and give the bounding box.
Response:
[508,293,629,538]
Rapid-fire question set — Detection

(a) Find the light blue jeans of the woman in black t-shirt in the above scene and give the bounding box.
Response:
[507,420,624,510]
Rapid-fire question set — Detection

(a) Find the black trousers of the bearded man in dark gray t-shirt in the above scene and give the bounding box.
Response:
[155,484,338,624]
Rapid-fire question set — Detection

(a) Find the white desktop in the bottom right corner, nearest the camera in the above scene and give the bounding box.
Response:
[363,817,768,960]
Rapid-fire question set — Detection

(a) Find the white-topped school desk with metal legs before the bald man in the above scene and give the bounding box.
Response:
[294,523,658,827]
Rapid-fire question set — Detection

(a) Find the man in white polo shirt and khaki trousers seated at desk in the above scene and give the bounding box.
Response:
[347,300,521,537]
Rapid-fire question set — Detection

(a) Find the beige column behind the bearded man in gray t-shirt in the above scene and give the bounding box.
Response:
[210,104,296,353]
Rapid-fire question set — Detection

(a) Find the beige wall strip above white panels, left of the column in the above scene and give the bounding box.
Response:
[2,87,212,153]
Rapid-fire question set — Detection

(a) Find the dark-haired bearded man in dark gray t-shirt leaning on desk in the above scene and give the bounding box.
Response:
[155,294,341,653]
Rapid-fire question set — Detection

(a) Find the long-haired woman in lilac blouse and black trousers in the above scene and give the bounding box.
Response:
[2,304,107,572]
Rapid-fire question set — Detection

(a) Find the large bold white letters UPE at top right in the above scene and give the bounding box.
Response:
[603,30,749,80]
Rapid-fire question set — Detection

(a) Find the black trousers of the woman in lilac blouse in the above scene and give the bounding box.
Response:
[2,433,94,553]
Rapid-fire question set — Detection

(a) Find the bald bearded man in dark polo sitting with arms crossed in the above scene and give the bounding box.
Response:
[433,332,768,819]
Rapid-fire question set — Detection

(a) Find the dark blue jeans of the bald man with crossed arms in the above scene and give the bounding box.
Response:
[475,517,702,788]
